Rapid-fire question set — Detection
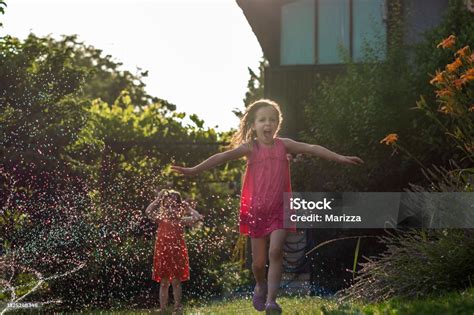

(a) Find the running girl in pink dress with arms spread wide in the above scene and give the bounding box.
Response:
[172,99,363,313]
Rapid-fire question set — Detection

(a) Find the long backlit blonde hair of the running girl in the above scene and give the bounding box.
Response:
[230,99,283,147]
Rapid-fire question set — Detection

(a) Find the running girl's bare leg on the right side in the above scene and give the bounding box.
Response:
[267,230,287,303]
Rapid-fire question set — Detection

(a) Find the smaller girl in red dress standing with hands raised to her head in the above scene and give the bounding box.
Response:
[146,189,202,312]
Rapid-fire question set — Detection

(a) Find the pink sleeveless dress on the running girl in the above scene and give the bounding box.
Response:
[240,138,294,238]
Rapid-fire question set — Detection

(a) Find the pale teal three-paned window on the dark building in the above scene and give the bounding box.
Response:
[280,0,386,65]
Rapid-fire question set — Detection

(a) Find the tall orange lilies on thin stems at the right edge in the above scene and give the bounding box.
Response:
[380,35,474,191]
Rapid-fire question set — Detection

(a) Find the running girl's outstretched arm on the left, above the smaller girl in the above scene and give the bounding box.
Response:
[171,144,250,176]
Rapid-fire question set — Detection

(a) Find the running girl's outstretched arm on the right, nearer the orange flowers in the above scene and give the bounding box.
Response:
[282,138,364,165]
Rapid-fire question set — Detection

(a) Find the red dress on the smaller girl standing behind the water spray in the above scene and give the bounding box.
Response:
[152,212,189,282]
